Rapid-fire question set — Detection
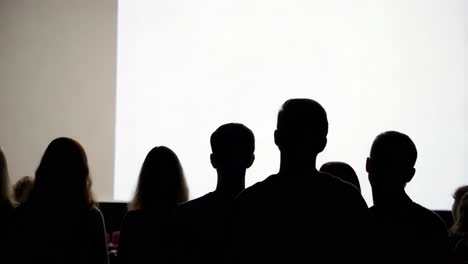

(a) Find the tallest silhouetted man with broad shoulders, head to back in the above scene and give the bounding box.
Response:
[232,99,370,263]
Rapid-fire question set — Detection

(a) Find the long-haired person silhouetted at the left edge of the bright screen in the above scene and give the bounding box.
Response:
[117,146,188,264]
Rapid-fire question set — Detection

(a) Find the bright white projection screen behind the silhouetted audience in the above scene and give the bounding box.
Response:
[114,0,468,209]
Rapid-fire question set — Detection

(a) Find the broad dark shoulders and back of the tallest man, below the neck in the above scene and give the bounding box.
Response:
[233,170,370,263]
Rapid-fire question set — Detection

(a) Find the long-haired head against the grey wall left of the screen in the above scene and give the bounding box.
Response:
[29,137,94,208]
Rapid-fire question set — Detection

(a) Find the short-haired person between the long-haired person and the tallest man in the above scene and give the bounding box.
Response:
[177,123,255,264]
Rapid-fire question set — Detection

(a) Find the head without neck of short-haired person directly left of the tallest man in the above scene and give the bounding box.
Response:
[210,123,255,170]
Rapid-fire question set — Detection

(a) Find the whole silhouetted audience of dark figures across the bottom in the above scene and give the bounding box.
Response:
[0,99,468,264]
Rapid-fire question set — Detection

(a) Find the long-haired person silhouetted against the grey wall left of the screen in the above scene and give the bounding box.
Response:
[12,138,108,264]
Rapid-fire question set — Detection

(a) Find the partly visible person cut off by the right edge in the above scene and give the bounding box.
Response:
[449,186,468,264]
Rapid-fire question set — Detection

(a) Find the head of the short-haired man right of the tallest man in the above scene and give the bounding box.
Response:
[366,131,418,189]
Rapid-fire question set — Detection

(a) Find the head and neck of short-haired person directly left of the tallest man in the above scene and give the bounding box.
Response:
[210,123,255,195]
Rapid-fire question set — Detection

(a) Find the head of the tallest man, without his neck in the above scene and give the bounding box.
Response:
[275,99,328,156]
